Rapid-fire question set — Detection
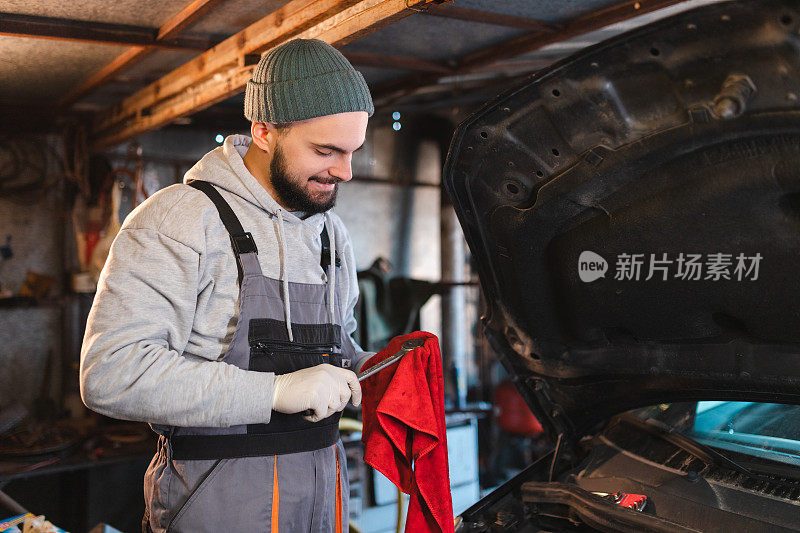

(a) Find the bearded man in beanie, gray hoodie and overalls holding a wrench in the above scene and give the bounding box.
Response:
[81,39,373,532]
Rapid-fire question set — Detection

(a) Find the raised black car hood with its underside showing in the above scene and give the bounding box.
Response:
[444,0,800,444]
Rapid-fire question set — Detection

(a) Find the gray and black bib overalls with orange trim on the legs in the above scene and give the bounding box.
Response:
[144,181,355,533]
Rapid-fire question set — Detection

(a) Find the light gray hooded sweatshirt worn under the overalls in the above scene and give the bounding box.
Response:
[80,135,372,427]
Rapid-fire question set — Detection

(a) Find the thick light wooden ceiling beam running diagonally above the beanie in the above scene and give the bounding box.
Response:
[92,0,454,151]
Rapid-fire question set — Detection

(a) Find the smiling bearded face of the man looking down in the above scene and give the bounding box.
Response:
[269,111,368,214]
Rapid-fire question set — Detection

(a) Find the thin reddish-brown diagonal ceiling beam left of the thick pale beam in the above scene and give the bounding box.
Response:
[58,0,222,107]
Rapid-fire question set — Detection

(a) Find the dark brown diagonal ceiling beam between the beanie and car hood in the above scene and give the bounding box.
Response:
[372,0,688,105]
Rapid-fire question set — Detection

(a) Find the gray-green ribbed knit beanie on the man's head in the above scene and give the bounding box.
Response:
[244,39,375,123]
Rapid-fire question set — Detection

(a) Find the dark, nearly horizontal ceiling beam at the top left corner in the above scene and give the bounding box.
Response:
[0,13,216,51]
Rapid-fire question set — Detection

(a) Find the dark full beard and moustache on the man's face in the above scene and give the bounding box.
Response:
[269,145,342,215]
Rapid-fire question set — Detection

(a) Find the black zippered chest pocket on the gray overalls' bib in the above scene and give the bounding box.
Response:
[248,318,350,375]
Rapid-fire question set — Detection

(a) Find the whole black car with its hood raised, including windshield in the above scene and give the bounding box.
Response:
[444,0,800,531]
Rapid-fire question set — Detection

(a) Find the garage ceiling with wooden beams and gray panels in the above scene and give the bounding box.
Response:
[0,0,714,150]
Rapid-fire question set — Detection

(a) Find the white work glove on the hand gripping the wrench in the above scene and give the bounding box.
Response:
[272,363,361,422]
